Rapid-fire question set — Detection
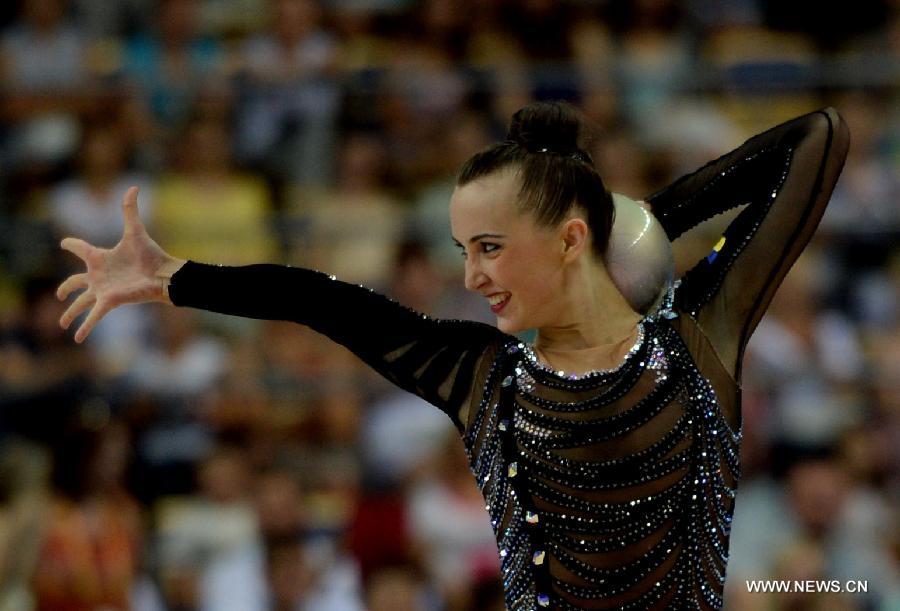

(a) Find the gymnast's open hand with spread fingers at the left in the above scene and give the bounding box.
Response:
[56,187,184,343]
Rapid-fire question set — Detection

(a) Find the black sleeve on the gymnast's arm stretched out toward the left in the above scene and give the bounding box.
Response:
[169,262,506,430]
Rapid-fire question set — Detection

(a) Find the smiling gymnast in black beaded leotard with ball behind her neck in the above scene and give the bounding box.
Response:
[58,102,849,611]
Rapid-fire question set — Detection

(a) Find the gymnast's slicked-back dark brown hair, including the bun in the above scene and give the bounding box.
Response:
[456,102,614,257]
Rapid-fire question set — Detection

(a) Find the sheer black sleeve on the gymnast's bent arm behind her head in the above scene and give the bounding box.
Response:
[647,108,849,380]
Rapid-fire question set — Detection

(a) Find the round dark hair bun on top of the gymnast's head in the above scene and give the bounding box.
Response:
[506,102,583,155]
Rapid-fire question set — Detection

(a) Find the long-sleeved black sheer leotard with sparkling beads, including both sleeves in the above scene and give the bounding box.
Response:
[169,110,848,611]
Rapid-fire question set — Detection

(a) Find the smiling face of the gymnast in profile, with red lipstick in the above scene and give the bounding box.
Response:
[450,170,565,333]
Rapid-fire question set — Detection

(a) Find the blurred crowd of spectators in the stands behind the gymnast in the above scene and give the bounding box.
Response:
[0,0,900,611]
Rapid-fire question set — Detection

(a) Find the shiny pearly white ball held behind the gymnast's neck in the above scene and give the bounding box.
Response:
[606,193,675,314]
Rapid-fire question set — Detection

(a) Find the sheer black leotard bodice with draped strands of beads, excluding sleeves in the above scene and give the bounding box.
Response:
[464,285,740,611]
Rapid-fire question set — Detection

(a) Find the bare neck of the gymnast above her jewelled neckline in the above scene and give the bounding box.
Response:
[534,261,642,369]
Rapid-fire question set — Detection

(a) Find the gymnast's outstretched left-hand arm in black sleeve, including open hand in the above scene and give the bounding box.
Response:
[57,189,507,429]
